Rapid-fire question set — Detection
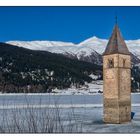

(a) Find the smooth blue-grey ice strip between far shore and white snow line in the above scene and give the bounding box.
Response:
[0,93,140,106]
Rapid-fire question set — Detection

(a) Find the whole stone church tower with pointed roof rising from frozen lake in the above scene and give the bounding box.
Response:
[103,23,131,123]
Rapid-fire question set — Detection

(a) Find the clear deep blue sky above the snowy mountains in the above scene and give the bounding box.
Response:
[0,7,140,43]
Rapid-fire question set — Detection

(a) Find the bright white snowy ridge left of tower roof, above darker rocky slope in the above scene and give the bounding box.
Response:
[6,36,107,56]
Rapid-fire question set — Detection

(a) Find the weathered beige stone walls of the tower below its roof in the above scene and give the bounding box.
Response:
[103,54,131,123]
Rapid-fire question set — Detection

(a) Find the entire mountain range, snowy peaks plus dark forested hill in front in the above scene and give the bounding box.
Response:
[0,36,140,93]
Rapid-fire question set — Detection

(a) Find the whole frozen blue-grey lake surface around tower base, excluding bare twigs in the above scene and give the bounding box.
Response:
[0,94,140,133]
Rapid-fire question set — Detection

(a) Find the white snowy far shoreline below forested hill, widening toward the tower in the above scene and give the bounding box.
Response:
[0,80,140,96]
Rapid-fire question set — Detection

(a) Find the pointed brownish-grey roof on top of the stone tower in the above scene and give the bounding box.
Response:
[103,24,130,55]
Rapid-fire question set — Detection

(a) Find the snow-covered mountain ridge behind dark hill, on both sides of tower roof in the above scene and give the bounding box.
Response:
[6,36,140,64]
